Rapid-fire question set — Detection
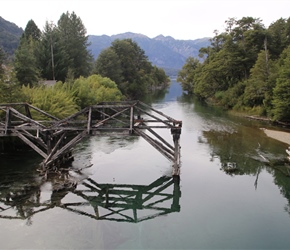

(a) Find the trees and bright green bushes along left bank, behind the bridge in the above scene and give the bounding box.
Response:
[0,12,169,117]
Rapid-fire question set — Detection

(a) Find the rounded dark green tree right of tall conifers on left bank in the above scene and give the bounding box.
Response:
[94,39,169,99]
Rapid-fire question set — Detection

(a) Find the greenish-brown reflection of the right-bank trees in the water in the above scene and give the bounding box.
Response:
[200,129,290,217]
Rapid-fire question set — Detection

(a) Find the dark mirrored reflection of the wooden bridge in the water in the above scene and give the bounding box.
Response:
[0,171,181,225]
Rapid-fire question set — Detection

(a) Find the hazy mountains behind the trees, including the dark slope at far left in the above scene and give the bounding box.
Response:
[0,17,210,76]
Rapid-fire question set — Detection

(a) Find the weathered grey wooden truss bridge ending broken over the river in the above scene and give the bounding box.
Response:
[0,101,182,176]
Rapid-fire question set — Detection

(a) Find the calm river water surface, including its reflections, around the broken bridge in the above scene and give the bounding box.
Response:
[0,81,290,249]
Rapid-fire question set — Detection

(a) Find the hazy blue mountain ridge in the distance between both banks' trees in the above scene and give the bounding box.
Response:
[88,32,210,75]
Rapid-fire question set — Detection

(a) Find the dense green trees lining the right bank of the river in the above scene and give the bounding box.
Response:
[178,17,290,122]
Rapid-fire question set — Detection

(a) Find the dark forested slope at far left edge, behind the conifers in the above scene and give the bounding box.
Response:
[0,16,23,56]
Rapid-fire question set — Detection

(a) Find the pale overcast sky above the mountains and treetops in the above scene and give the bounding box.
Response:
[0,0,290,40]
